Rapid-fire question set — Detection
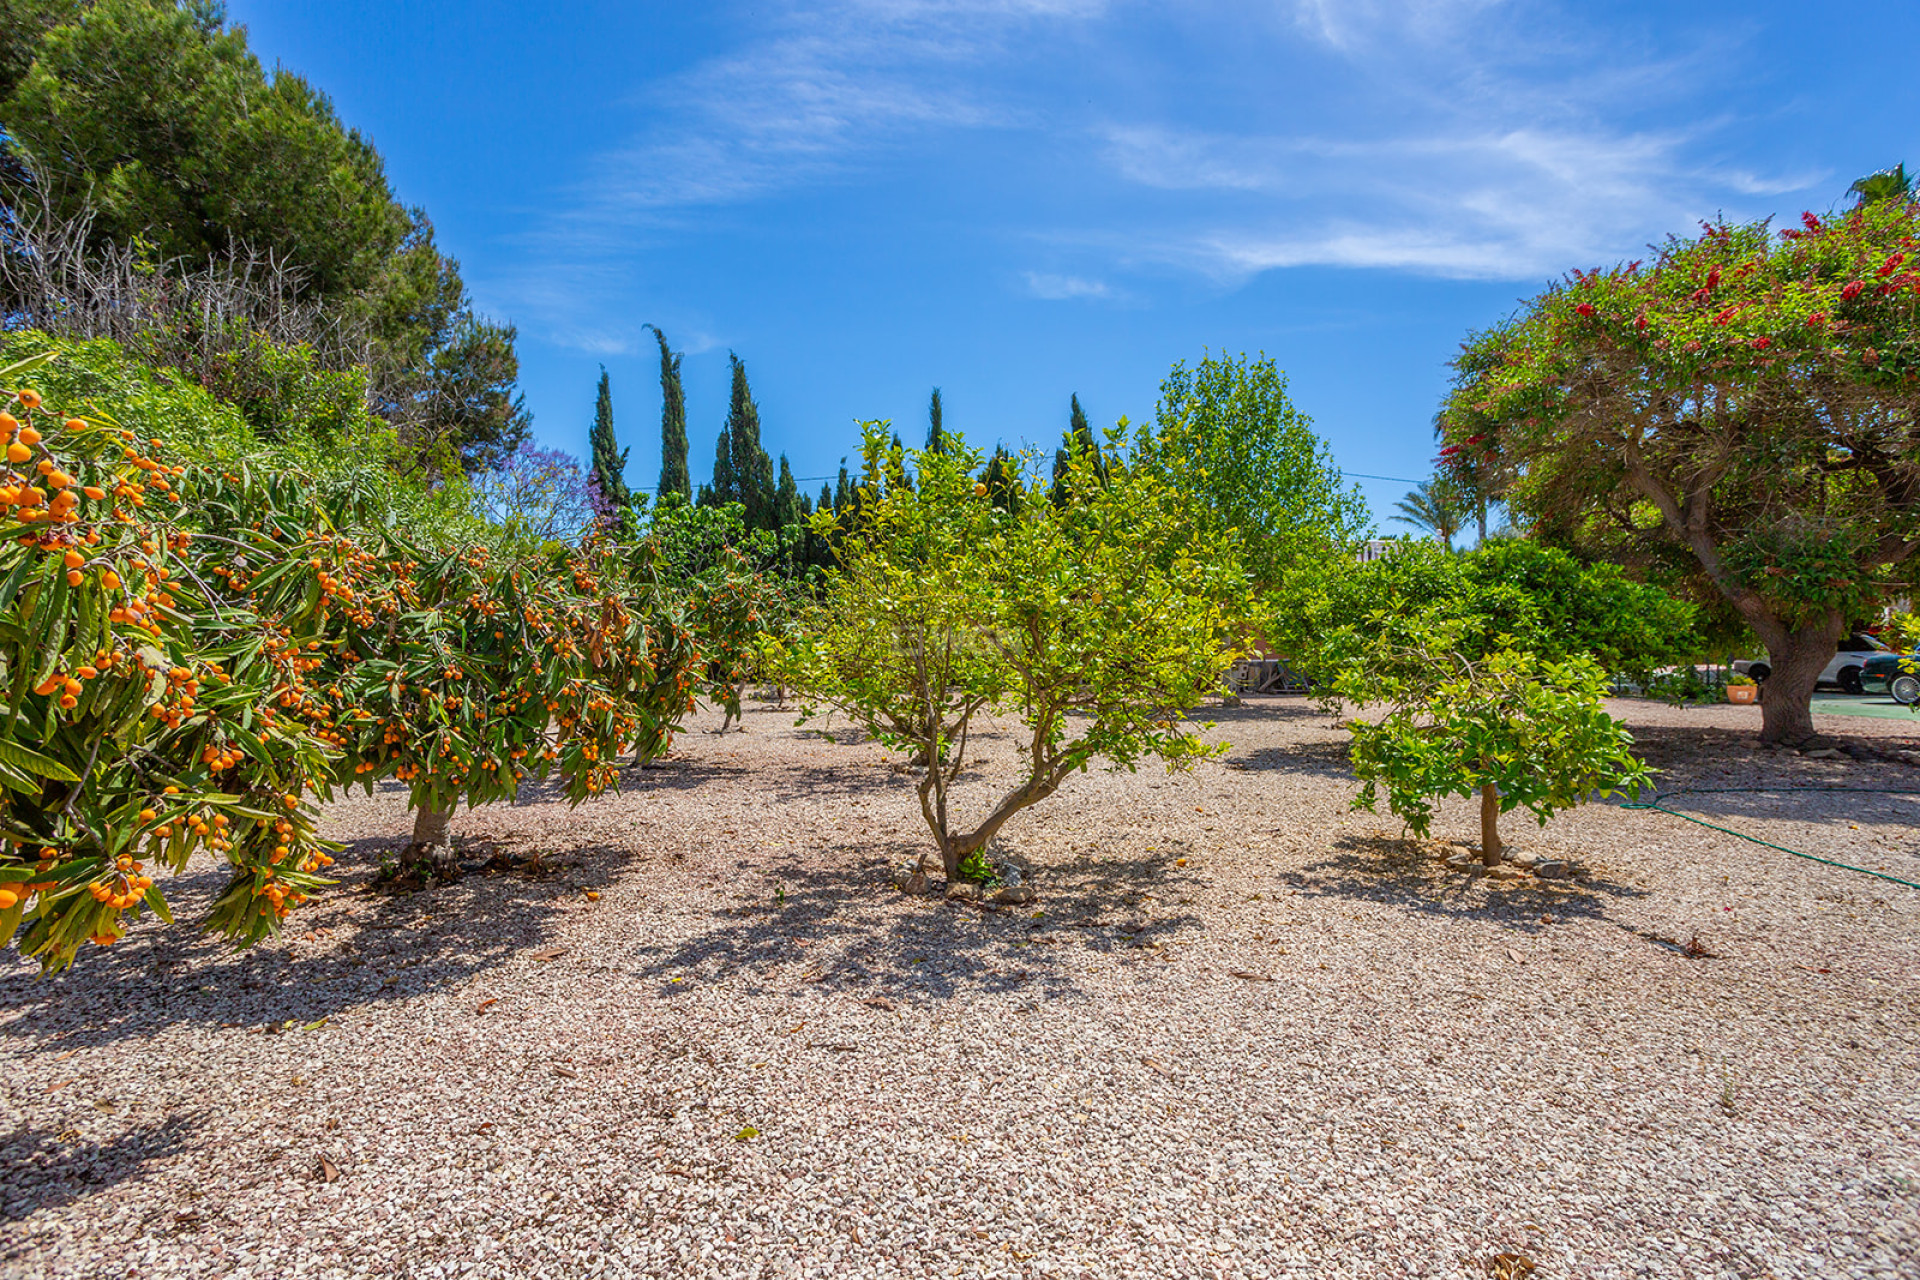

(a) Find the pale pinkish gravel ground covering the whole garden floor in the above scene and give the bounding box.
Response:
[0,700,1920,1280]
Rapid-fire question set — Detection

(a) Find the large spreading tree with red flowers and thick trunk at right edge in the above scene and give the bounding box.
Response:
[1442,198,1920,745]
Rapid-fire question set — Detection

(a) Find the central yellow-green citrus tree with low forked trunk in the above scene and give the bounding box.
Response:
[785,424,1248,881]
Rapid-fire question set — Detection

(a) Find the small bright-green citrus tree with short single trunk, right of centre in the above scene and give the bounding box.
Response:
[1338,614,1649,865]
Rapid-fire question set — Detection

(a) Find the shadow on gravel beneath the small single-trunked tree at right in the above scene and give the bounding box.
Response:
[1283,835,1647,933]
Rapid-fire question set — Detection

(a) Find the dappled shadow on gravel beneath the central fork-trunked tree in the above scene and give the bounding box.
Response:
[634,841,1196,1002]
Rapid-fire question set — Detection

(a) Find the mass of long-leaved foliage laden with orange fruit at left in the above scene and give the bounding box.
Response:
[0,349,697,969]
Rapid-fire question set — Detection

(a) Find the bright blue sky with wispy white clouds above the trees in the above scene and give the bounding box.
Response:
[230,0,1920,512]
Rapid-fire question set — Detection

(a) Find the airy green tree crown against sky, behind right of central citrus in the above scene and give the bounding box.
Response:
[1135,355,1371,587]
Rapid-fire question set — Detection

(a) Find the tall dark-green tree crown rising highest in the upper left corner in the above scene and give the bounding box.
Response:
[0,0,530,470]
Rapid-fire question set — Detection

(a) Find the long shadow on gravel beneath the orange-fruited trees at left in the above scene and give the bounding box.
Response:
[0,839,639,1054]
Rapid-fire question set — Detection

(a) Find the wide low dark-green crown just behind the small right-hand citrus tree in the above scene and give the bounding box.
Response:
[1265,539,1701,693]
